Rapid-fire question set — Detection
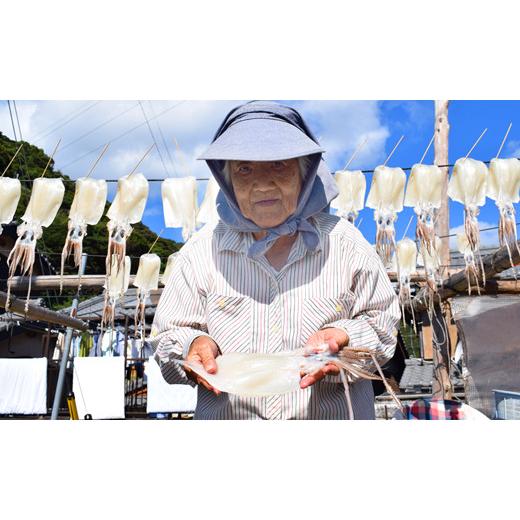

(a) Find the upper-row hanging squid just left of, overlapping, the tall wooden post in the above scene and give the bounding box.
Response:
[404,164,443,254]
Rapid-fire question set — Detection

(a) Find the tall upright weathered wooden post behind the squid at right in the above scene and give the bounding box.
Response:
[432,101,453,399]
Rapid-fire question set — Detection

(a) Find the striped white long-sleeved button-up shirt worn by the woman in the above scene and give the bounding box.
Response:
[151,213,400,419]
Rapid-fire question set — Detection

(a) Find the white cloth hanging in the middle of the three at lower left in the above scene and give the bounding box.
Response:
[72,356,125,419]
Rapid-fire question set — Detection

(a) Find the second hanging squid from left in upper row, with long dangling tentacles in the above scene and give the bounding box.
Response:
[7,177,65,312]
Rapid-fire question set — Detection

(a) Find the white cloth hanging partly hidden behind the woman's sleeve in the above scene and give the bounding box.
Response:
[144,356,197,413]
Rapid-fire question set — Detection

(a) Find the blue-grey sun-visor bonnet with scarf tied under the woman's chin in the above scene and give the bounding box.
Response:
[199,101,338,257]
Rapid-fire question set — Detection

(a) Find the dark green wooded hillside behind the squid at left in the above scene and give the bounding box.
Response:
[0,132,182,308]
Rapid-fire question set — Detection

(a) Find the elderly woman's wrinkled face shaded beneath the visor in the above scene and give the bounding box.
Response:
[230,159,302,228]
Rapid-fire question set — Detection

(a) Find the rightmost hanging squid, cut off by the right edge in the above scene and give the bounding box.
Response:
[487,158,520,264]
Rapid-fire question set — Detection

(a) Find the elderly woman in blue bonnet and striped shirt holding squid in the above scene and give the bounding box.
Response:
[151,102,399,419]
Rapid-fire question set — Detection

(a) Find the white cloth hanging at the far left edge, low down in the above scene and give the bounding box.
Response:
[0,358,47,414]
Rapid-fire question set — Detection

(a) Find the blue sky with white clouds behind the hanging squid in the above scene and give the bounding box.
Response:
[0,100,520,253]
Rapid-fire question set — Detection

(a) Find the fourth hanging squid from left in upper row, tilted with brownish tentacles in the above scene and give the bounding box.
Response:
[106,173,148,274]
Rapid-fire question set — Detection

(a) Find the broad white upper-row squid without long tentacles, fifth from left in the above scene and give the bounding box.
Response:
[161,177,197,242]
